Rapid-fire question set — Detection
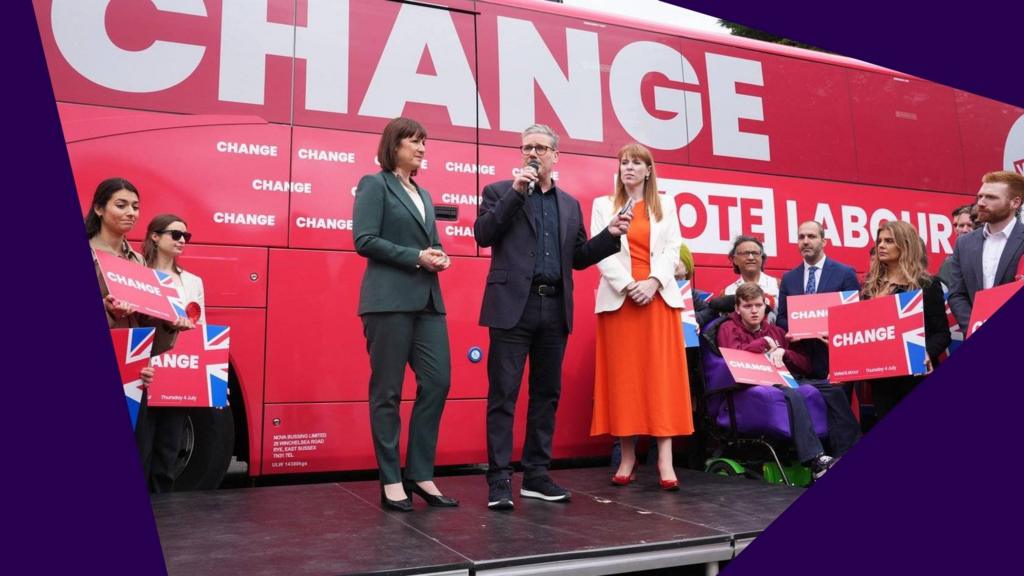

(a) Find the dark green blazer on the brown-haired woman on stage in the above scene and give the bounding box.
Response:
[352,171,444,316]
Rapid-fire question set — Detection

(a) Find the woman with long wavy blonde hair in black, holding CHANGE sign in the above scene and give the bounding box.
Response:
[860,220,950,420]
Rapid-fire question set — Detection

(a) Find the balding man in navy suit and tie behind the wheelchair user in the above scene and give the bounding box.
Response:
[775,220,860,379]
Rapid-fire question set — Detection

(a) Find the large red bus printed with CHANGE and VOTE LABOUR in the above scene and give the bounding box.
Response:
[35,0,1024,488]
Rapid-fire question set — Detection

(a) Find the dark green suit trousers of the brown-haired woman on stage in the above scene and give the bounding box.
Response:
[362,311,452,484]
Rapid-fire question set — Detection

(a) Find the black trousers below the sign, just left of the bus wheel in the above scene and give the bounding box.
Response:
[135,403,188,494]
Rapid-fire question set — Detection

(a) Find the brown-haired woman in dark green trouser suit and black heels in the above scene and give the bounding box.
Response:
[352,118,459,511]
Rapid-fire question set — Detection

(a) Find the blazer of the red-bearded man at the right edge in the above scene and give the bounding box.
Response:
[949,219,1024,334]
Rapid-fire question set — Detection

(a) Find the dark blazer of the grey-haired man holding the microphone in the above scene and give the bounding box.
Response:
[473,180,621,332]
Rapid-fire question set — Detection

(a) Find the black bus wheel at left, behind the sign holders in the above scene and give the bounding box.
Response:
[174,406,234,491]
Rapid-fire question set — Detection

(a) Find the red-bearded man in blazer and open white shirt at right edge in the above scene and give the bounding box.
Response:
[949,170,1024,334]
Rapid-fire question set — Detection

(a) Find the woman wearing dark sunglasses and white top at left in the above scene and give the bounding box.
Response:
[136,214,206,493]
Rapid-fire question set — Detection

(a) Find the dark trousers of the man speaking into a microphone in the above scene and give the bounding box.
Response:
[487,293,568,483]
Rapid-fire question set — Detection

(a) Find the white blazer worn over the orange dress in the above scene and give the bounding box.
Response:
[590,195,683,313]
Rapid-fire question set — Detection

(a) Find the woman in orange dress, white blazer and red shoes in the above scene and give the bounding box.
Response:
[590,143,693,490]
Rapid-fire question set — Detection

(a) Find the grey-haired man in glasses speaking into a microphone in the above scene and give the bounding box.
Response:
[474,124,630,509]
